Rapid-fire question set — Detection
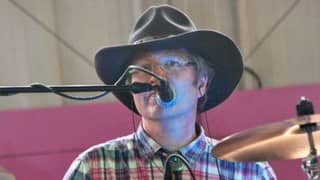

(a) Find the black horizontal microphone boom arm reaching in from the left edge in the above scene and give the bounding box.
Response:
[0,83,153,96]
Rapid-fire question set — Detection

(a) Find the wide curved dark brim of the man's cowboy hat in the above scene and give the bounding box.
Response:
[95,30,243,114]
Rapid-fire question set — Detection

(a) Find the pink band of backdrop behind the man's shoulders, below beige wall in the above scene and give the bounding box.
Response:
[0,85,320,180]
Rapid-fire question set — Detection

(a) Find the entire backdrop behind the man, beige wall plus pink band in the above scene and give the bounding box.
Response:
[0,0,320,179]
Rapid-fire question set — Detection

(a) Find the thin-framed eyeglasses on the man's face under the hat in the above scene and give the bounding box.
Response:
[129,56,196,77]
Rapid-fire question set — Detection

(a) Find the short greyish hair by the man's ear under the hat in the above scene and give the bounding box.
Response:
[186,50,214,113]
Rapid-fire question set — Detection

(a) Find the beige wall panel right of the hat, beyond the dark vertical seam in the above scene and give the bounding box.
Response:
[239,0,320,87]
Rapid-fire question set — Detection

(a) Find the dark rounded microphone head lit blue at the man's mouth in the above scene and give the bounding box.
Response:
[156,80,176,107]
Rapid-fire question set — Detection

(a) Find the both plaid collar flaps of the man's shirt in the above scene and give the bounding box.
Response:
[136,124,210,166]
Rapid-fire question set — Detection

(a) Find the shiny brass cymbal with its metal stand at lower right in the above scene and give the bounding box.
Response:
[211,97,320,180]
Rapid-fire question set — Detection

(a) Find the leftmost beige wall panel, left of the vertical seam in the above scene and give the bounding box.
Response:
[0,0,62,109]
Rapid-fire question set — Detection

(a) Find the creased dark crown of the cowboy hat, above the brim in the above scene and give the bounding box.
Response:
[129,5,197,44]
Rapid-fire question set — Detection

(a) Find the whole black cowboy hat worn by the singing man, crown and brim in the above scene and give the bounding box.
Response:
[95,5,243,114]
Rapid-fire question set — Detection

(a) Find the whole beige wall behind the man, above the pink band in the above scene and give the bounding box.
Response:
[0,0,320,109]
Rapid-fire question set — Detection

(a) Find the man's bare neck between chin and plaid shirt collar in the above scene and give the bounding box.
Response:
[142,115,197,151]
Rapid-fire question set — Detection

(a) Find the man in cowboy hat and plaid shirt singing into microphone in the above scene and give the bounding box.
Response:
[64,5,276,179]
